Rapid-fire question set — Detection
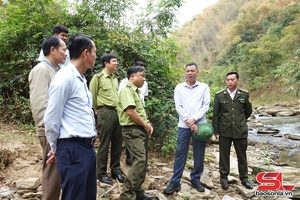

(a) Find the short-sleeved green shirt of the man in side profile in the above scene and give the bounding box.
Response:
[117,81,148,126]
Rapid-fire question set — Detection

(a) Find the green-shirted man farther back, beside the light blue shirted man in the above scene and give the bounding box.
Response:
[89,54,126,184]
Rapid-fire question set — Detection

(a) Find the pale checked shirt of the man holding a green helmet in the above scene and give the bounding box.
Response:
[174,81,210,128]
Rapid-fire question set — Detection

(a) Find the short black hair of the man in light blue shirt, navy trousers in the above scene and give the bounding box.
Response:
[68,34,93,60]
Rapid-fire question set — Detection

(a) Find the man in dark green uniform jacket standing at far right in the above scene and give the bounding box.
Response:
[212,72,253,190]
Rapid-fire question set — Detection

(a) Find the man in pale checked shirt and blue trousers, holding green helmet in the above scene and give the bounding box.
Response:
[164,63,210,194]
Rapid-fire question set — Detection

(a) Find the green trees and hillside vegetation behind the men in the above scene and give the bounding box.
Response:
[0,0,300,155]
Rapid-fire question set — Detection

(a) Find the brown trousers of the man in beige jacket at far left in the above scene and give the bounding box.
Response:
[39,136,60,200]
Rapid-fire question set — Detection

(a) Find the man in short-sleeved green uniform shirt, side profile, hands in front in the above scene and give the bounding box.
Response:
[117,66,154,200]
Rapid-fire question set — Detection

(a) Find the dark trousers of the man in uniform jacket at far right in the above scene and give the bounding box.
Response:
[219,136,248,182]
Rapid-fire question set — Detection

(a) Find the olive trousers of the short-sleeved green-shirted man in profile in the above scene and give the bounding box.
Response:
[120,126,148,200]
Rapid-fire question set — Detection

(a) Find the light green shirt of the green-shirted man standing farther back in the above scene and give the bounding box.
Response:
[89,70,118,110]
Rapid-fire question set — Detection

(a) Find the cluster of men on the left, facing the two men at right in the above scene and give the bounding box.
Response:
[28,25,154,200]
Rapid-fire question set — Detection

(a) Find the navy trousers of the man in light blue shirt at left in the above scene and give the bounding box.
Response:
[56,140,97,200]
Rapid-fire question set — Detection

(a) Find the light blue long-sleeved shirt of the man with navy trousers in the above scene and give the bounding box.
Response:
[44,63,97,153]
